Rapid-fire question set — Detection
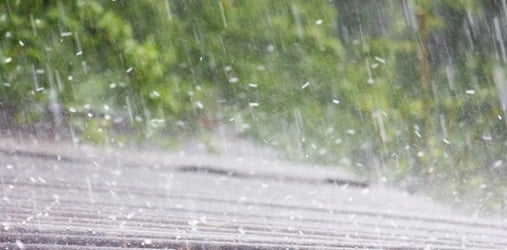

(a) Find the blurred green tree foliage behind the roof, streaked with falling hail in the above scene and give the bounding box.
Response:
[0,0,507,213]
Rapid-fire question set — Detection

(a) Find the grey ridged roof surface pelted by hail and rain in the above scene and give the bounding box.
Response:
[0,139,507,250]
